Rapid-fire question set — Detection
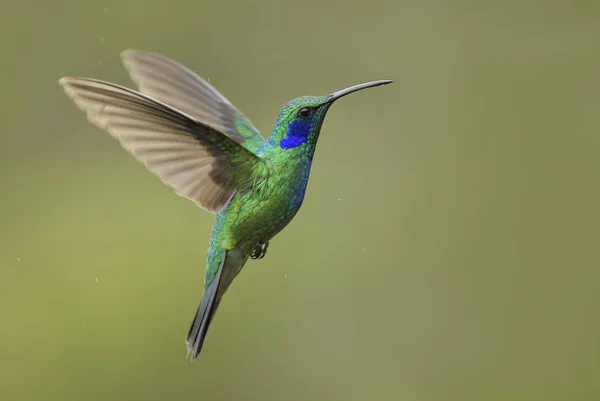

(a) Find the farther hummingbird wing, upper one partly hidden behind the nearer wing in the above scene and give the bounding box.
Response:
[121,50,265,152]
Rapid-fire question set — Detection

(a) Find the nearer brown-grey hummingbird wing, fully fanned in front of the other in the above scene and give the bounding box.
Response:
[59,77,262,213]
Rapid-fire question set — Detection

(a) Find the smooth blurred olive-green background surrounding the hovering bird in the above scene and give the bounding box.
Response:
[0,0,600,401]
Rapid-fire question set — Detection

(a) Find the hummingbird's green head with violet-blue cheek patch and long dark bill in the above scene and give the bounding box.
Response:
[269,80,394,149]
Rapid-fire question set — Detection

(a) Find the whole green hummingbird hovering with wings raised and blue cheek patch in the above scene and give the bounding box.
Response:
[59,50,393,360]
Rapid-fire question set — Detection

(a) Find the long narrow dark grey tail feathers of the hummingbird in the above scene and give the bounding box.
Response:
[187,255,227,360]
